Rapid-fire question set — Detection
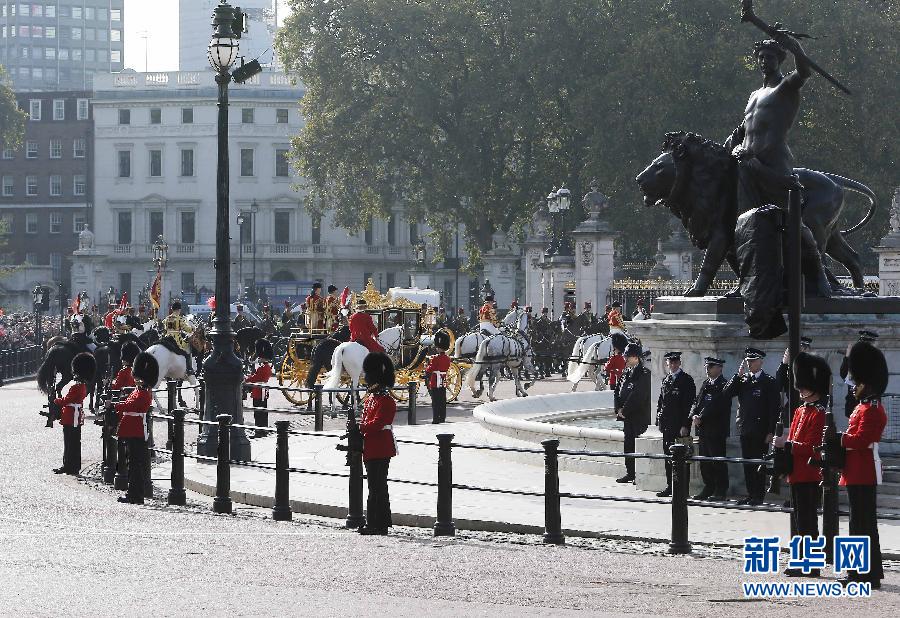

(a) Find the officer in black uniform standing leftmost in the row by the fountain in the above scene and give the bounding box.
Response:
[616,343,650,483]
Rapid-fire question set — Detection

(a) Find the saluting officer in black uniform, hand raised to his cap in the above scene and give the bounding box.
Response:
[724,348,781,505]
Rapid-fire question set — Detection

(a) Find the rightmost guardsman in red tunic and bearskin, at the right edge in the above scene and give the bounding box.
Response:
[825,341,889,588]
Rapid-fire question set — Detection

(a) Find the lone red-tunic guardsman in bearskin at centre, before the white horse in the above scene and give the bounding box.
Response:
[359,352,397,534]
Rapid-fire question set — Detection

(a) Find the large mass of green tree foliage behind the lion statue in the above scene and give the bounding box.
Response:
[278,0,900,268]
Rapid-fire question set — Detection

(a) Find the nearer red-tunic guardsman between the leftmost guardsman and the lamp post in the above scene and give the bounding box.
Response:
[115,352,159,504]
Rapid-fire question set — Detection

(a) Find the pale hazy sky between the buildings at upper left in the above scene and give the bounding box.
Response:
[125,0,287,71]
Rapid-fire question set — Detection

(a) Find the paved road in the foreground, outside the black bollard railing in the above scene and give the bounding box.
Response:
[0,383,900,616]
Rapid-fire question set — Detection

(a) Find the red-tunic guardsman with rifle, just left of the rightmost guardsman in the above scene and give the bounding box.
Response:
[772,352,831,577]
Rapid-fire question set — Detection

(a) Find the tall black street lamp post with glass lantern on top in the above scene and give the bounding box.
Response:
[197,2,259,461]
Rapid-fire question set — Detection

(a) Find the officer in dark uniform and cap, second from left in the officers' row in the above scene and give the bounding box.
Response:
[656,352,697,498]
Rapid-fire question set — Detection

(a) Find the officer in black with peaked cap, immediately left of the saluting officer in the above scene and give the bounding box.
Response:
[691,356,731,501]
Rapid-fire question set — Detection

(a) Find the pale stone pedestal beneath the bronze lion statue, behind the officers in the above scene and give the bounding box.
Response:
[628,297,900,494]
